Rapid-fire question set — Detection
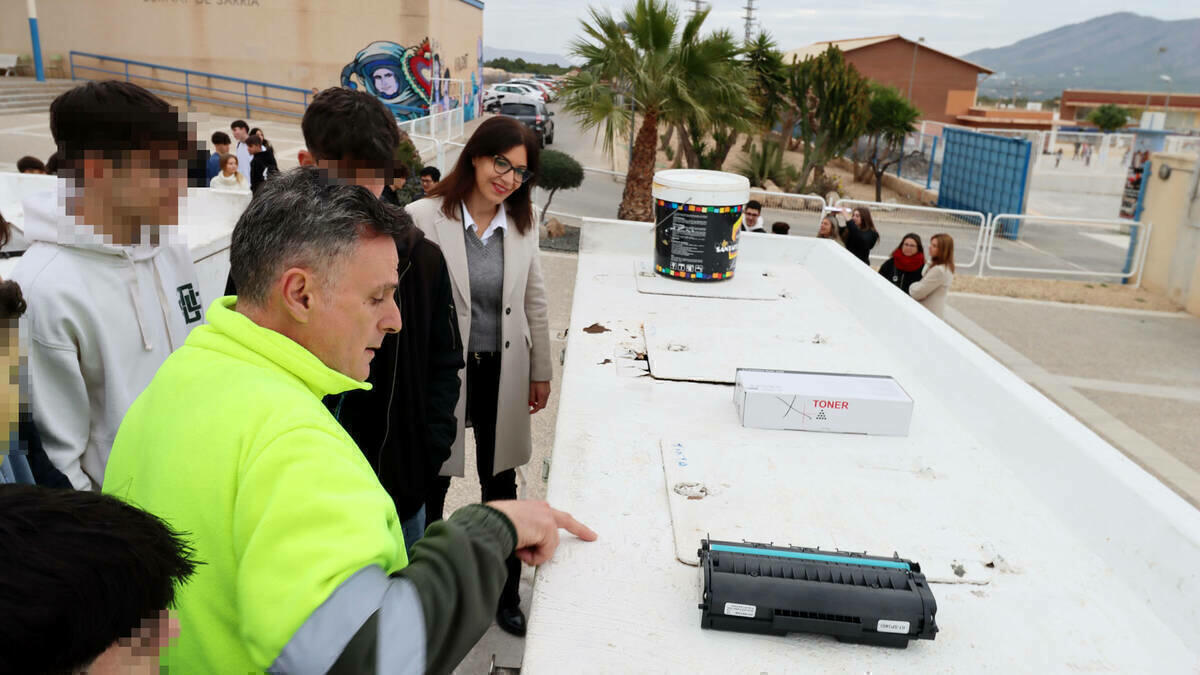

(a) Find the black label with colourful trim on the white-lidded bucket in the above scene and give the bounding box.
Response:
[654,199,743,281]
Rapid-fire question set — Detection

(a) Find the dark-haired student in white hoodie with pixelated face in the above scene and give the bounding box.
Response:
[12,80,203,490]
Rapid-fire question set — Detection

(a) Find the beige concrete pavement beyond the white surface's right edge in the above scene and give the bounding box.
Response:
[946,294,1200,506]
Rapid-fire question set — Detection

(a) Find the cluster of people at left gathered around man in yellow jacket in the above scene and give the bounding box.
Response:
[0,80,595,673]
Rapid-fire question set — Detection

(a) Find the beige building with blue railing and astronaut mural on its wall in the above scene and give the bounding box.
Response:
[0,0,484,117]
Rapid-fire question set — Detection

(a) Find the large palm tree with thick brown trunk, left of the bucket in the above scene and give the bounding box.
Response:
[563,0,744,221]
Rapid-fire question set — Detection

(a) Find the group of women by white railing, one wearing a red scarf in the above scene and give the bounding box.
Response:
[817,207,954,317]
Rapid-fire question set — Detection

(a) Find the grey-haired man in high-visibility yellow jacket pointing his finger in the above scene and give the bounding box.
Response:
[104,169,595,673]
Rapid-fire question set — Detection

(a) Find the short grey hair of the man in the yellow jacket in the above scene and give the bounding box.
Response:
[229,167,413,305]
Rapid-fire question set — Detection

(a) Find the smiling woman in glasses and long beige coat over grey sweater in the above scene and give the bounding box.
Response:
[407,117,551,635]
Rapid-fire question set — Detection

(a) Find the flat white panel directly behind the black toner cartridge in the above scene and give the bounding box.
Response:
[660,437,993,583]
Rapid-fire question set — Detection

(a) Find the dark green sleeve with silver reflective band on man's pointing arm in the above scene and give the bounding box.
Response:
[270,504,516,674]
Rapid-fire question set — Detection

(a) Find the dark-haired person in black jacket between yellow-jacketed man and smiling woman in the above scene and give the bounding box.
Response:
[226,86,466,548]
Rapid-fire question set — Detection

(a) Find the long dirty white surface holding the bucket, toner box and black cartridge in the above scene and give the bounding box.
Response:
[522,221,1200,674]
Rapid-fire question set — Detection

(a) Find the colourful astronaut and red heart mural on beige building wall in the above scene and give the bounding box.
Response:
[342,38,460,120]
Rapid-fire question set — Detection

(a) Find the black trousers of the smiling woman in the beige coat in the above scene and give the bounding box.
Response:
[425,352,521,608]
